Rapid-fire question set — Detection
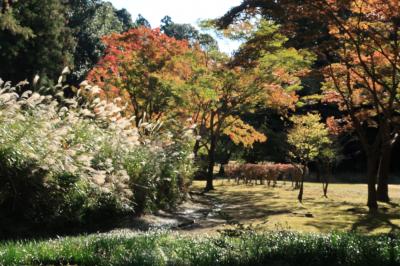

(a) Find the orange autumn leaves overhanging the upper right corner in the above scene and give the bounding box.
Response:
[325,0,399,133]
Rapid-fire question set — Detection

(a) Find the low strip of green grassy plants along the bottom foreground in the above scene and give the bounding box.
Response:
[0,230,400,266]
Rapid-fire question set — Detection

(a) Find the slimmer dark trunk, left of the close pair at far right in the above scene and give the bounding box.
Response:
[367,153,378,212]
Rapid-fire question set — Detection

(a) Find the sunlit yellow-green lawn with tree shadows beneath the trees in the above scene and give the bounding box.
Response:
[193,180,400,234]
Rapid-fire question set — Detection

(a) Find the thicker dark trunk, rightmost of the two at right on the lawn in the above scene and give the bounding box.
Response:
[377,144,392,202]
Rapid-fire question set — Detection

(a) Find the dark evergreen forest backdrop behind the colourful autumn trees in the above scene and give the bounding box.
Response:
[0,0,400,175]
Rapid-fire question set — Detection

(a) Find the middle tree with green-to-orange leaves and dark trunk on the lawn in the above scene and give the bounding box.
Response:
[186,21,312,190]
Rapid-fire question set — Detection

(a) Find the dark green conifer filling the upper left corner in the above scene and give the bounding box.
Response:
[0,0,75,82]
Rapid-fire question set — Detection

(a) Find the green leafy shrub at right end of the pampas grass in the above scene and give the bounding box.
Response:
[124,121,194,213]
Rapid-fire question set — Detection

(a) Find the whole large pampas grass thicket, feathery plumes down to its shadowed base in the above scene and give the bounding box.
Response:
[0,77,192,231]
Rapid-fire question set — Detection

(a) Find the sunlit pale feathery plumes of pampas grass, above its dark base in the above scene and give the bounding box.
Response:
[0,77,193,212]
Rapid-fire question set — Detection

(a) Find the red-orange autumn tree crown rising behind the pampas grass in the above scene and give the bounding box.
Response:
[88,27,190,124]
